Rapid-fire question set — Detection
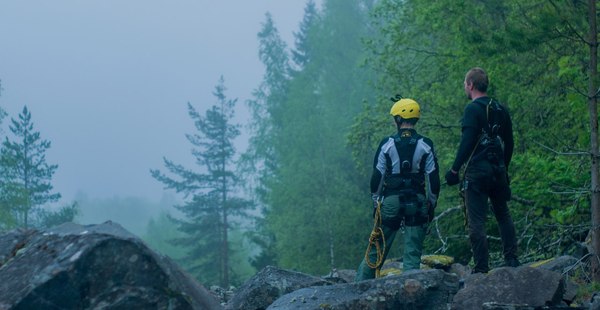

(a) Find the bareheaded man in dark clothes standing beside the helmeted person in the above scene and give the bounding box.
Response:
[445,67,520,273]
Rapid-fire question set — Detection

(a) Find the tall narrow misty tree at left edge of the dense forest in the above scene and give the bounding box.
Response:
[243,13,290,269]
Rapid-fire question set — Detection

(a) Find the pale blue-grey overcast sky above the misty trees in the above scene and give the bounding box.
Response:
[0,0,319,202]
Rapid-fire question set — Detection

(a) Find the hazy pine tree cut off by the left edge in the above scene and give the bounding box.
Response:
[0,106,61,228]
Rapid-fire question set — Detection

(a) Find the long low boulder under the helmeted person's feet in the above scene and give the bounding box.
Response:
[267,269,459,310]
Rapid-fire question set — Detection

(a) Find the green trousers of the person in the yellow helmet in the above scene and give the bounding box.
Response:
[354,195,427,282]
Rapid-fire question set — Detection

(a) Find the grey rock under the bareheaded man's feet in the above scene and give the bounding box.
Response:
[452,266,565,310]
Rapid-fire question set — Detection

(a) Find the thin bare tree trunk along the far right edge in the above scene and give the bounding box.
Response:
[588,0,600,282]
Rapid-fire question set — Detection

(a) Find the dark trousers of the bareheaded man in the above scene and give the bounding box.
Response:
[465,161,517,272]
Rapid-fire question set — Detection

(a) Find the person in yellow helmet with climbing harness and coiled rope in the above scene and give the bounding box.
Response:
[355,98,440,281]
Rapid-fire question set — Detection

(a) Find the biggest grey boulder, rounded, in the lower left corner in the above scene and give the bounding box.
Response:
[0,222,222,309]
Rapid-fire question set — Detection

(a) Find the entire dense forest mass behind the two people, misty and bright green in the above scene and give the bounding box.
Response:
[241,0,590,273]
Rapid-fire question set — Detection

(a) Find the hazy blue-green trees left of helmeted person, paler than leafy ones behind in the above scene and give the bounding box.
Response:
[245,0,380,273]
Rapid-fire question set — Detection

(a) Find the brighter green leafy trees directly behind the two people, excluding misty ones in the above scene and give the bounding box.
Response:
[352,0,590,268]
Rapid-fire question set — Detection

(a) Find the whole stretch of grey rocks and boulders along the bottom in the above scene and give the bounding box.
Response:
[0,222,600,310]
